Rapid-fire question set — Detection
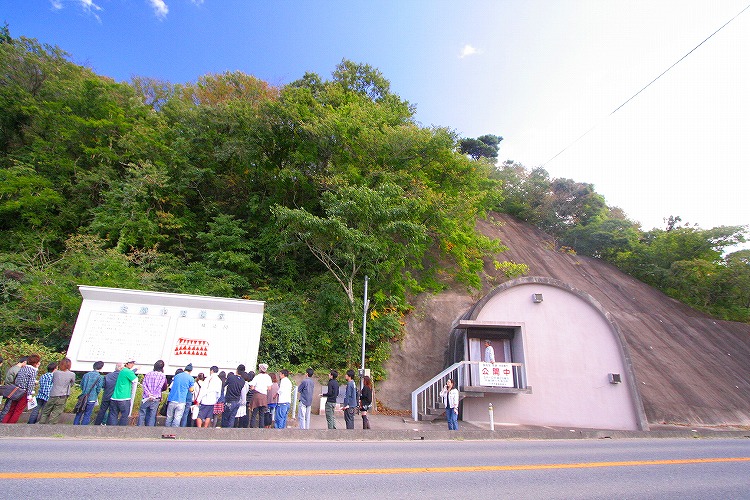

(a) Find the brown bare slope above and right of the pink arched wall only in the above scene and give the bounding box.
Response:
[478,214,750,425]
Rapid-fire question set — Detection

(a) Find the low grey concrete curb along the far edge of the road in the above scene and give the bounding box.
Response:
[0,424,750,441]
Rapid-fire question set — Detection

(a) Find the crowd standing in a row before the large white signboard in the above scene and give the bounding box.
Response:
[0,354,372,429]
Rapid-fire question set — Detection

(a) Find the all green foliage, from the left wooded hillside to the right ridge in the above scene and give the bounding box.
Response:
[0,27,750,377]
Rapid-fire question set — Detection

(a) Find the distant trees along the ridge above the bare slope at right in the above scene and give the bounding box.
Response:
[495,162,750,322]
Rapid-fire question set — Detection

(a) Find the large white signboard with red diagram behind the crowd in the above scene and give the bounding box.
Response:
[68,286,264,375]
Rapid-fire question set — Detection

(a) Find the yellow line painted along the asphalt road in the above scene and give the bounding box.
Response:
[0,457,750,479]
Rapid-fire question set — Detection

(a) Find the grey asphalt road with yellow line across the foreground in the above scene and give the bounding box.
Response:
[0,438,750,500]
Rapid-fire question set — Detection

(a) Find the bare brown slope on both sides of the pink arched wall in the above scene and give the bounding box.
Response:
[378,214,750,425]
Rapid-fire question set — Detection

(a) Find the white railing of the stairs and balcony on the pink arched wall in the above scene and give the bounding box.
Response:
[411,361,526,421]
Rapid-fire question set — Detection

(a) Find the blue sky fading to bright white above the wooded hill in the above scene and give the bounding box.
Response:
[0,0,750,238]
